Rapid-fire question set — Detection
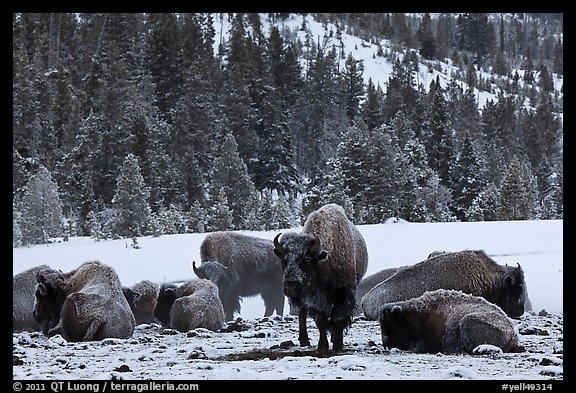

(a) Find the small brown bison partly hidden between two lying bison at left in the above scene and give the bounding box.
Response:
[122,280,160,325]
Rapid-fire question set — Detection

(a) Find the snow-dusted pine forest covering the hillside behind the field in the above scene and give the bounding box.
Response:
[12,13,563,247]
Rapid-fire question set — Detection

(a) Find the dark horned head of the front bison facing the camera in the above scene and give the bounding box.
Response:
[274,233,328,297]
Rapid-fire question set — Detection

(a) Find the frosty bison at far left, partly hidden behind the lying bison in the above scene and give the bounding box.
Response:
[12,265,50,332]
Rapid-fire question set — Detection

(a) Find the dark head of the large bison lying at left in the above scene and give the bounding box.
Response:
[32,269,66,335]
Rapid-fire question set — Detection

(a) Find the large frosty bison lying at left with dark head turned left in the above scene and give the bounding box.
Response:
[34,261,135,341]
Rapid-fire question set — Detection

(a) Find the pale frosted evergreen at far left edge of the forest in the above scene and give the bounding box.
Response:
[20,165,63,244]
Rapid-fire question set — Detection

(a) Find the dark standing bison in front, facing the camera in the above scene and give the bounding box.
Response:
[274,204,368,351]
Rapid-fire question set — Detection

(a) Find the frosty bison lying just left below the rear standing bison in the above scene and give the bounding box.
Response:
[170,278,224,332]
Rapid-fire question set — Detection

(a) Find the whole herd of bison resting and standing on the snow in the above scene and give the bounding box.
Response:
[13,204,544,354]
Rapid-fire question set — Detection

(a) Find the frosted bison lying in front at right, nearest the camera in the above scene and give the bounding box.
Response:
[378,289,524,354]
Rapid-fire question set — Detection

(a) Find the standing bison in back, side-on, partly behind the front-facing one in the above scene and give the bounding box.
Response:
[192,232,285,321]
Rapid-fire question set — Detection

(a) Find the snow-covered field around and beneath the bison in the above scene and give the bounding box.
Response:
[13,220,563,380]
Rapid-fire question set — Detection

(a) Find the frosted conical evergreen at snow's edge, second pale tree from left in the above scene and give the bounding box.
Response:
[112,154,151,237]
